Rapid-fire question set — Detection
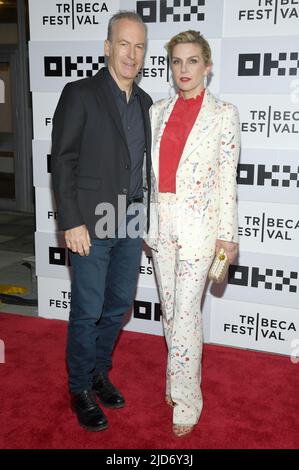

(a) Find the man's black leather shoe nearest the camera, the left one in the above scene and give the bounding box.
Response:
[72,390,108,431]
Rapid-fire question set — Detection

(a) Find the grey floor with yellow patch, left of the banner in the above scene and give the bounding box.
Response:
[0,211,37,316]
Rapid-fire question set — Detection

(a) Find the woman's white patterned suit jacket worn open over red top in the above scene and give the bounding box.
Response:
[146,89,240,259]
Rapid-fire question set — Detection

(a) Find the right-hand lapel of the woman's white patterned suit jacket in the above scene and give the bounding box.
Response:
[179,89,218,167]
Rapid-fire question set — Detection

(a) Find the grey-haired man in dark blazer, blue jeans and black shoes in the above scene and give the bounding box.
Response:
[52,12,152,431]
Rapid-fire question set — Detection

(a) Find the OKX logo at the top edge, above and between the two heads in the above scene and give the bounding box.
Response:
[136,0,206,23]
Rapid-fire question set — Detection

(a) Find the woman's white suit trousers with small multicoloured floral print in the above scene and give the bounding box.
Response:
[153,193,213,424]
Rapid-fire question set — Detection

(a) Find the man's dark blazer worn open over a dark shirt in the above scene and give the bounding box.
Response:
[51,69,152,237]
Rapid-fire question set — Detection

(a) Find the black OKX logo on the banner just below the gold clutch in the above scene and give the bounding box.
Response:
[228,265,298,294]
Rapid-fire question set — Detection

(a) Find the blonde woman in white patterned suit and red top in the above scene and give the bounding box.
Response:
[147,31,240,436]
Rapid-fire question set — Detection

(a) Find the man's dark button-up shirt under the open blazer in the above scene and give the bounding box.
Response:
[105,68,145,198]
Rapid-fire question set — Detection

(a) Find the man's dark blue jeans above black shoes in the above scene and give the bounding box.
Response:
[67,216,142,393]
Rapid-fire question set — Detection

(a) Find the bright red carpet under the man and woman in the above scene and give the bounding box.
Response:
[0,314,299,449]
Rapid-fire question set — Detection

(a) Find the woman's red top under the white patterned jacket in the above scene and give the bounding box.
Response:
[159,90,205,193]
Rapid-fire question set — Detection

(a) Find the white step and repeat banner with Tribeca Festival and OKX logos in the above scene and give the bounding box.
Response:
[29,0,299,355]
